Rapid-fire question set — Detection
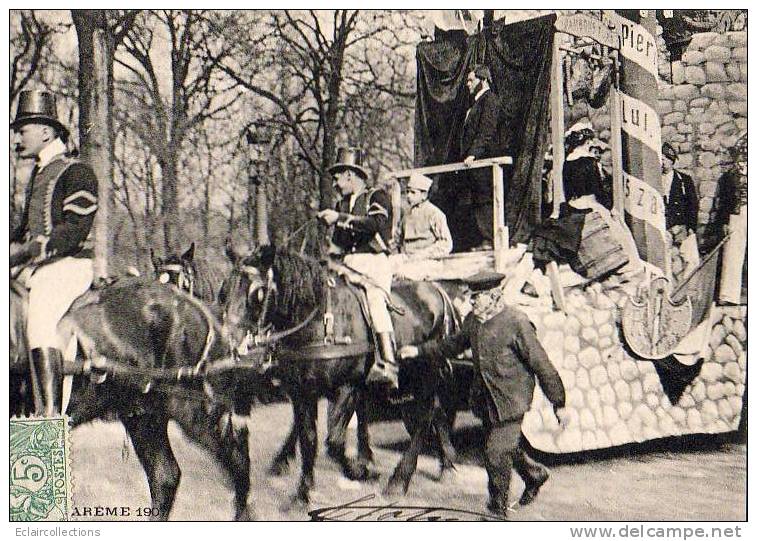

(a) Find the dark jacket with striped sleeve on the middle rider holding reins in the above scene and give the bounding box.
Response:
[331,189,392,254]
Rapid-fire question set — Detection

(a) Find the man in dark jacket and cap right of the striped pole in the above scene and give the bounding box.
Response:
[661,142,699,235]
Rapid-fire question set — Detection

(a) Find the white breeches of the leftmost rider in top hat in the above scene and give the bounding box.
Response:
[26,257,94,349]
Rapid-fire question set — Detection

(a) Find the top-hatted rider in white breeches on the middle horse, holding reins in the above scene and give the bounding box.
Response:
[318,147,399,389]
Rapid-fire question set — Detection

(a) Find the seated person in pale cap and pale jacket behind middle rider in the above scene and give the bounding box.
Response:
[400,173,452,259]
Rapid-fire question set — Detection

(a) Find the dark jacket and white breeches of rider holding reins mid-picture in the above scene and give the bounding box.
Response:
[331,189,393,333]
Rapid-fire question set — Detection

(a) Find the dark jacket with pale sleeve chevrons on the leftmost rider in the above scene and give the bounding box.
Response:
[11,154,97,261]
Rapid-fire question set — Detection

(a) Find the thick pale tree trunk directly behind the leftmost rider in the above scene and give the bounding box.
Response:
[71,10,113,277]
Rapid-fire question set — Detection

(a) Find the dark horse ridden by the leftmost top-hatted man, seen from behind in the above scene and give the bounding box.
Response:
[10,279,252,520]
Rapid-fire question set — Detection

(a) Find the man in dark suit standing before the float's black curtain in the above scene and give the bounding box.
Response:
[460,65,501,250]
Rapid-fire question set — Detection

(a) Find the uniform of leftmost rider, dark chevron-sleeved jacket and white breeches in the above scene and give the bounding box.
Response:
[11,140,97,349]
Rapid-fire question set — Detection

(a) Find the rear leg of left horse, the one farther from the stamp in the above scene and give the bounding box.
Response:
[171,401,254,520]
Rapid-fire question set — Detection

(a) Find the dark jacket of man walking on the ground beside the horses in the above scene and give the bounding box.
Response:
[420,307,565,423]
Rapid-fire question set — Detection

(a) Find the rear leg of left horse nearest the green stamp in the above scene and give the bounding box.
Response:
[122,414,181,520]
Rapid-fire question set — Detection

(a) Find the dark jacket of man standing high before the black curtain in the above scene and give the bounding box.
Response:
[460,89,501,160]
